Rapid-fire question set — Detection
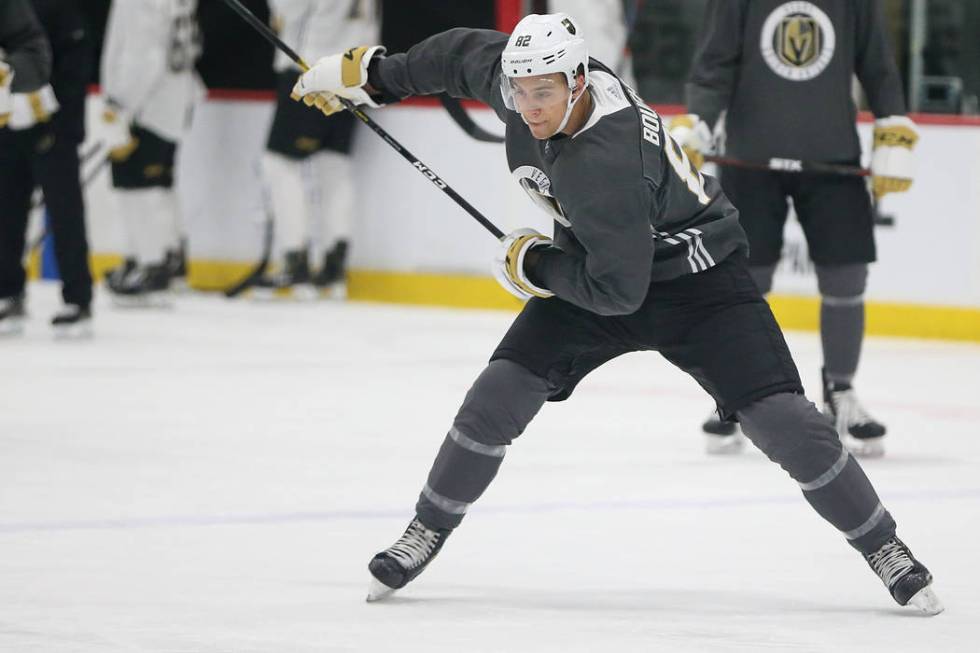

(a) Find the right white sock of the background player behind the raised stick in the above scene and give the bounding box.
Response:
[313,151,354,250]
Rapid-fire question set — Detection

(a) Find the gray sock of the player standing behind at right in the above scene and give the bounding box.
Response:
[816,263,868,385]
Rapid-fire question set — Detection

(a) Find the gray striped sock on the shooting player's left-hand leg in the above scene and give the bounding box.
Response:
[415,360,553,530]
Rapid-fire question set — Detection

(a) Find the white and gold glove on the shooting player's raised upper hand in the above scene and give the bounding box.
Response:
[292,45,386,116]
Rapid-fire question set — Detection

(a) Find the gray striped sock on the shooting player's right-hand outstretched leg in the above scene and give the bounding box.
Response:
[738,393,895,554]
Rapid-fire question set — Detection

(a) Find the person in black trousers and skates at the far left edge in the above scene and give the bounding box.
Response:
[0,0,92,337]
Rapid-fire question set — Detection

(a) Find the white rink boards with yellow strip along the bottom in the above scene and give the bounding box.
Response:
[55,94,980,341]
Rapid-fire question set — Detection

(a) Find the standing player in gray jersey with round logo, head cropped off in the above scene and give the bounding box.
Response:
[671,0,918,456]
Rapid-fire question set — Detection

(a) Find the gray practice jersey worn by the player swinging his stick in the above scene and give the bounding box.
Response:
[370,28,747,315]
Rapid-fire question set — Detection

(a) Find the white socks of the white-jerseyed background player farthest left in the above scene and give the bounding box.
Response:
[118,188,176,265]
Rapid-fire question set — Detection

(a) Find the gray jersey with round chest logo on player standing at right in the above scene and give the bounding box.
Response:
[687,0,905,161]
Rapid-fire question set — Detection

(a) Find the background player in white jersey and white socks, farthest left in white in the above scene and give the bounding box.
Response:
[101,0,203,304]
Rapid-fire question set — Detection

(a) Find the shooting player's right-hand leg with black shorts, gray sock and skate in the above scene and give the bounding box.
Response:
[661,259,936,611]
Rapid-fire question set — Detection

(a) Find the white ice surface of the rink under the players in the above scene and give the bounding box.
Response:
[0,284,980,653]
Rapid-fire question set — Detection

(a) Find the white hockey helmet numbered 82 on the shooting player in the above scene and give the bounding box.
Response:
[500,13,589,133]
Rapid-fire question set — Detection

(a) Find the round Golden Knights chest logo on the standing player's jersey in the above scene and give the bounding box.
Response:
[759,1,836,82]
